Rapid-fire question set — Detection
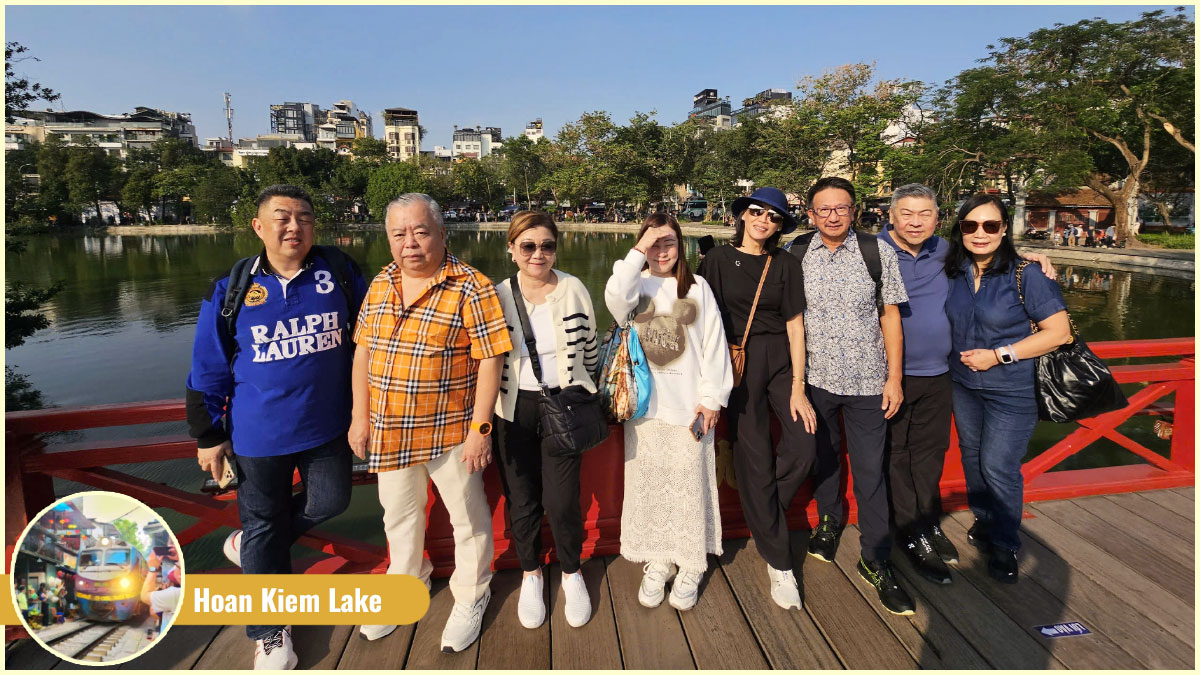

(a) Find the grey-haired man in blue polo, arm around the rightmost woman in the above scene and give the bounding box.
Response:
[878,183,1055,584]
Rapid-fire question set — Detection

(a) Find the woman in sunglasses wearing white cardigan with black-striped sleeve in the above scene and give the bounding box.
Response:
[496,211,599,628]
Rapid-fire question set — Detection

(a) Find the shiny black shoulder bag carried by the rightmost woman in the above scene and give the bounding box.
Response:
[1016,261,1129,423]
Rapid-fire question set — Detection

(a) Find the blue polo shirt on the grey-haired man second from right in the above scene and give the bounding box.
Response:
[880,227,950,377]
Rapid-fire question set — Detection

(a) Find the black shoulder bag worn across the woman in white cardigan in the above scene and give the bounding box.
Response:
[509,274,608,458]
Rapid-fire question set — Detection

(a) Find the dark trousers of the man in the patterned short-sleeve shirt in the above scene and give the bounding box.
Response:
[809,387,892,561]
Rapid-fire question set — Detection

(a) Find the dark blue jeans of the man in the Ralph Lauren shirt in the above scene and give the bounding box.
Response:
[238,434,352,640]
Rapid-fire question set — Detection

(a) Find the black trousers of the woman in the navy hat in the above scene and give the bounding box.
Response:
[728,334,815,571]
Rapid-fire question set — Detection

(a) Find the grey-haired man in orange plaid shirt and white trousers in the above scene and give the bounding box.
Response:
[348,193,512,653]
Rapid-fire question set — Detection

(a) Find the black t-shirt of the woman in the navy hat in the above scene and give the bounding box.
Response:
[696,244,804,344]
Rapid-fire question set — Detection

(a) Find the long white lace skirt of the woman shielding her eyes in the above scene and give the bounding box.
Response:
[620,418,721,572]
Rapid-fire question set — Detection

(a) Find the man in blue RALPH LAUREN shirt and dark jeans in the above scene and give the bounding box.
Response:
[187,185,367,670]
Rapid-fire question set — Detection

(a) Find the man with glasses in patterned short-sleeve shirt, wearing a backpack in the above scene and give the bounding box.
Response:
[802,178,913,614]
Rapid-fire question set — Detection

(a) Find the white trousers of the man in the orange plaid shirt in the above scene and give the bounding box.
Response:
[379,444,493,604]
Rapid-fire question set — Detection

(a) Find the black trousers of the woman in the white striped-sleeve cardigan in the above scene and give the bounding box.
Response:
[494,389,583,574]
